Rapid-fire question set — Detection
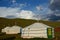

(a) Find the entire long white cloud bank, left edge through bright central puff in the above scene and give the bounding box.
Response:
[0,7,35,19]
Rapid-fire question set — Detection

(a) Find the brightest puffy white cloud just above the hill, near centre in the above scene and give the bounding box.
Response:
[19,10,35,19]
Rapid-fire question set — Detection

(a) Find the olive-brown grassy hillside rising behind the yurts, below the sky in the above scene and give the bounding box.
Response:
[0,18,60,29]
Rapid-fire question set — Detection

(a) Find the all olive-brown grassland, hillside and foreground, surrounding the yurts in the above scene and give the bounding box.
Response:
[0,18,60,40]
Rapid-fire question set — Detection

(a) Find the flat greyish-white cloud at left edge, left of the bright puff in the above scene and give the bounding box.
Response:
[0,7,20,17]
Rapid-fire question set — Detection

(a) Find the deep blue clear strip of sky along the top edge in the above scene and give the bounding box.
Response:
[0,0,49,7]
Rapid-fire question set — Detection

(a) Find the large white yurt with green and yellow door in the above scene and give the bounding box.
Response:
[21,22,54,38]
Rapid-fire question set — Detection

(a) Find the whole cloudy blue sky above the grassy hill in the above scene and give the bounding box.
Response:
[0,0,60,21]
